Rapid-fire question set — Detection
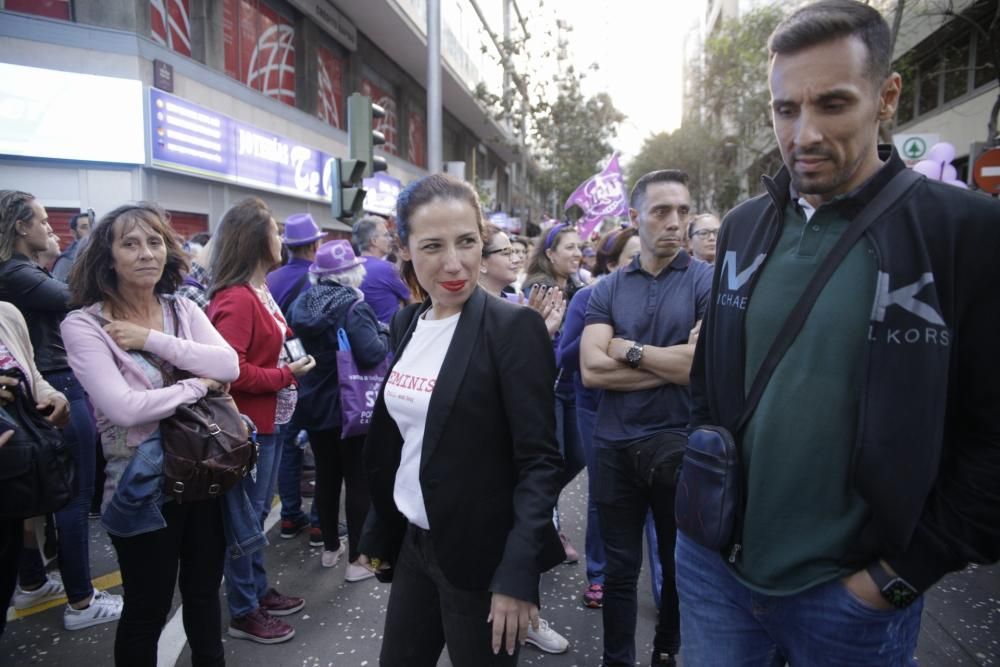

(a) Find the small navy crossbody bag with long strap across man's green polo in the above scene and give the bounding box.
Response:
[674,169,921,563]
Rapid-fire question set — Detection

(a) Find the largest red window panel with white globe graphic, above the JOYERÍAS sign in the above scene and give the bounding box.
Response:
[222,0,295,106]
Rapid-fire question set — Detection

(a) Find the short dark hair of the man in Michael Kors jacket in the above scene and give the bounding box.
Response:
[767,0,892,86]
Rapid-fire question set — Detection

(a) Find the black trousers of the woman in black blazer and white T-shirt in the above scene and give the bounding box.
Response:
[379,525,520,667]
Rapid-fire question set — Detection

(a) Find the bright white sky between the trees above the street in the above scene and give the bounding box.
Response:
[545,0,704,164]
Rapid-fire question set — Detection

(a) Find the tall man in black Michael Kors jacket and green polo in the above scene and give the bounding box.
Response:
[677,0,1000,665]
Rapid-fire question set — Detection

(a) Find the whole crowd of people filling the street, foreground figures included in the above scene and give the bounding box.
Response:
[0,5,1000,667]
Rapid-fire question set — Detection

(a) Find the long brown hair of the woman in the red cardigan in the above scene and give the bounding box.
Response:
[208,197,274,298]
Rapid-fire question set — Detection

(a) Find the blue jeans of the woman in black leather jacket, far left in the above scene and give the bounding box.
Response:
[20,371,97,603]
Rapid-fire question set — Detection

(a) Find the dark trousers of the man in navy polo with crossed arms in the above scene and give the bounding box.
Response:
[595,444,681,667]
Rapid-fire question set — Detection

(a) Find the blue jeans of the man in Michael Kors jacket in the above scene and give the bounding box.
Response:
[676,532,923,667]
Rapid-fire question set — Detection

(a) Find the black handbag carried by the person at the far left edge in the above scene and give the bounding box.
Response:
[0,369,77,519]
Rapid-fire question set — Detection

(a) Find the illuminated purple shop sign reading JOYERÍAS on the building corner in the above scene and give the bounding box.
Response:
[149,88,333,201]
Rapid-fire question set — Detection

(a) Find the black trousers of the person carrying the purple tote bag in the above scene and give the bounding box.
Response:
[309,428,369,563]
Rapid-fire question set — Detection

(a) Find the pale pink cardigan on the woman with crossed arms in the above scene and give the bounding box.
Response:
[60,295,240,447]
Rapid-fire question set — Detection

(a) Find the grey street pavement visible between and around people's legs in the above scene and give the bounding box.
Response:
[0,473,1000,667]
